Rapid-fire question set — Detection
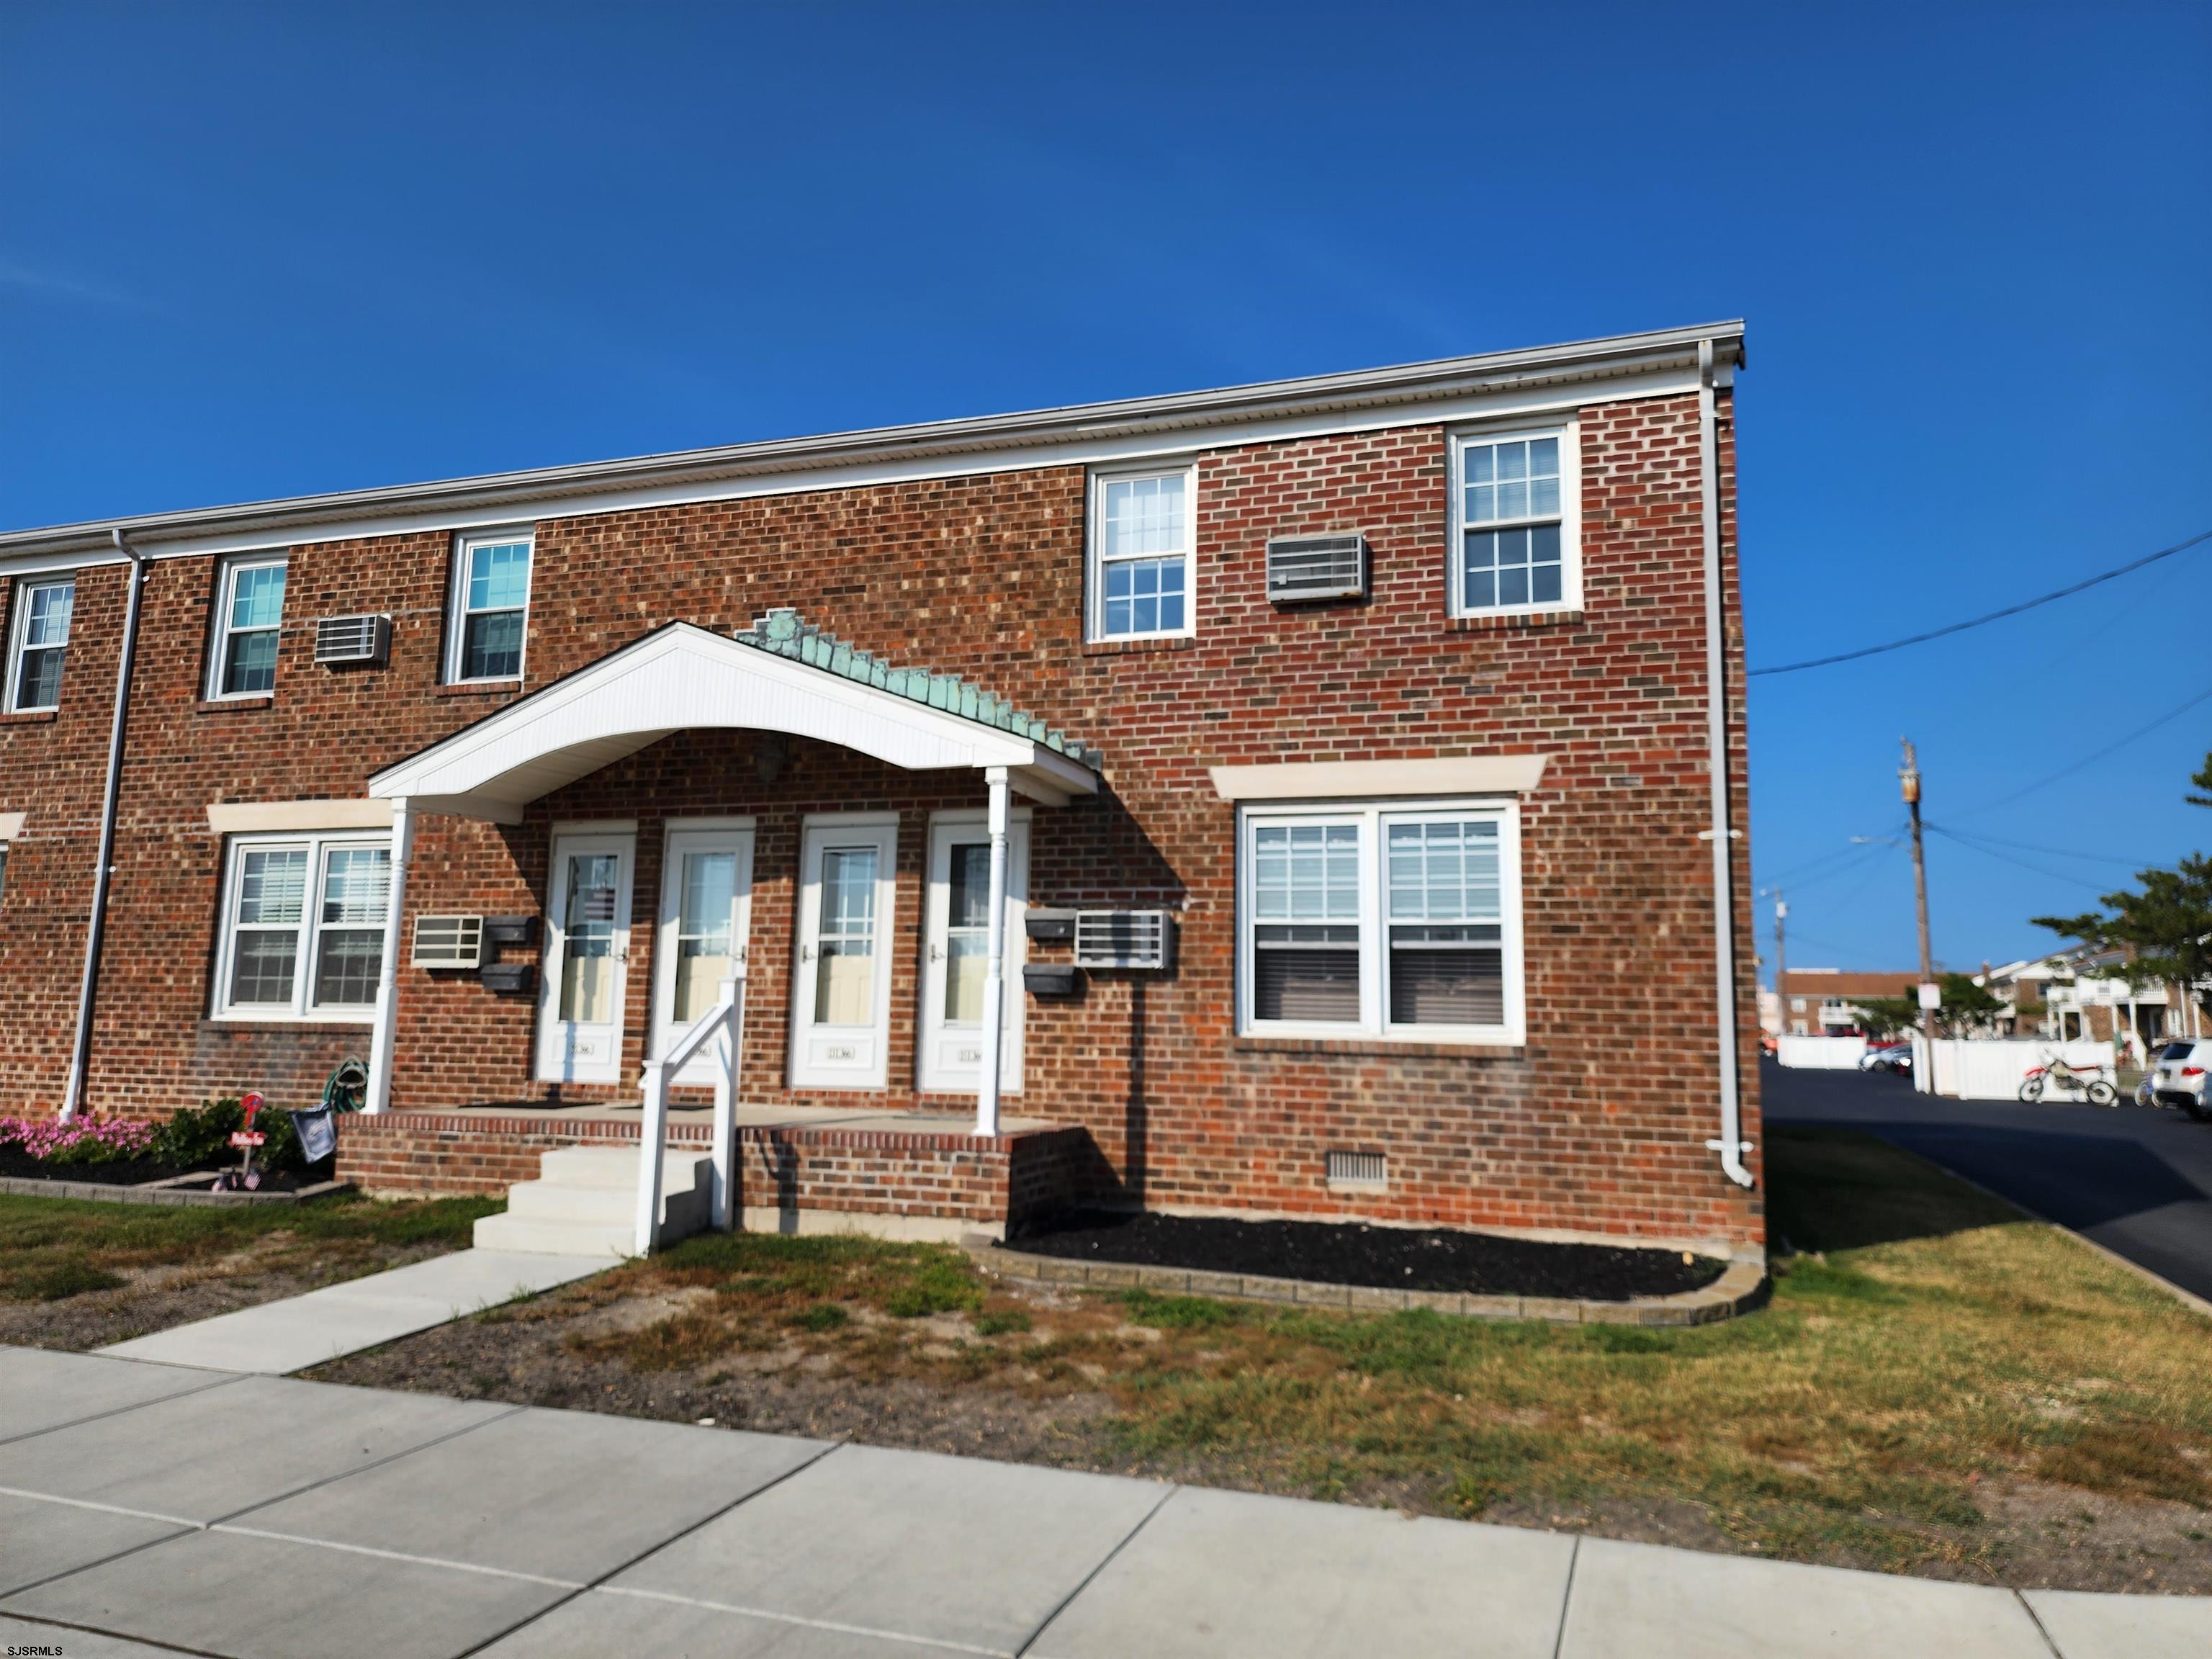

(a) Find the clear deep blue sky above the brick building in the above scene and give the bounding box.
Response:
[0,0,2212,966]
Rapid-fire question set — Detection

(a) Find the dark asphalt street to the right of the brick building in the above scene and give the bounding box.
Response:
[1761,1059,2212,1298]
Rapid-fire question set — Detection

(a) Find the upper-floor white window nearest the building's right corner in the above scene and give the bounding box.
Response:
[1449,421,1581,617]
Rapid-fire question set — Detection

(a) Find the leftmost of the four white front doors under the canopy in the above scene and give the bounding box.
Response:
[537,834,637,1084]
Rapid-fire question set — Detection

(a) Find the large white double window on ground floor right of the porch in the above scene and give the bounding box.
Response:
[1236,801,1524,1044]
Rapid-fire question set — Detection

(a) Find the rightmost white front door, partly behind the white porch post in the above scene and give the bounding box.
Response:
[918,814,1028,1095]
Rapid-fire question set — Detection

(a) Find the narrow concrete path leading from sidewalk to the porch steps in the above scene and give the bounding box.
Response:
[99,1250,615,1376]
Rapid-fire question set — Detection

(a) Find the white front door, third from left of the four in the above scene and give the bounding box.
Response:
[792,817,898,1088]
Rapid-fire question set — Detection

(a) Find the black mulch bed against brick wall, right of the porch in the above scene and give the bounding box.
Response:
[1007,1210,1727,1303]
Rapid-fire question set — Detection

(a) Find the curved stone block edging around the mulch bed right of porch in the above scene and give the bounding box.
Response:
[960,1232,1774,1325]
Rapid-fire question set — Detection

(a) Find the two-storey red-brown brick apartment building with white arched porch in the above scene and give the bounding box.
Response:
[0,325,1761,1241]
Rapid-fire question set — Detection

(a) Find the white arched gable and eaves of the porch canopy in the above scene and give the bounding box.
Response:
[369,621,1097,823]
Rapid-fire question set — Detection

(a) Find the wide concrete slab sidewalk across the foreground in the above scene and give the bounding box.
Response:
[0,1349,2212,1659]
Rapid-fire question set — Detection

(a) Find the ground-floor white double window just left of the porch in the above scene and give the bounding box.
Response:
[212,834,392,1024]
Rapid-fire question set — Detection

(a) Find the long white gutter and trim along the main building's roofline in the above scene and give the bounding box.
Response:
[0,320,1743,573]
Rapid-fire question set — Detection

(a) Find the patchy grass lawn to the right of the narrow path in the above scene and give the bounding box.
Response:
[302,1128,2212,1591]
